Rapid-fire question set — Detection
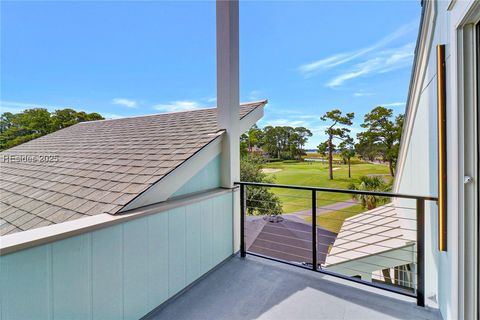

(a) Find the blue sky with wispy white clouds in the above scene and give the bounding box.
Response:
[0,1,421,148]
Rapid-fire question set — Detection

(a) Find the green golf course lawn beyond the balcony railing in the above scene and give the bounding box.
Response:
[264,161,390,232]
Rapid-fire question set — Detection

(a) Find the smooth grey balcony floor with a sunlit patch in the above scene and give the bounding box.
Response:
[149,256,441,320]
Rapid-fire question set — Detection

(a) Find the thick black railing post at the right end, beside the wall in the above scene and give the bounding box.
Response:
[417,199,425,307]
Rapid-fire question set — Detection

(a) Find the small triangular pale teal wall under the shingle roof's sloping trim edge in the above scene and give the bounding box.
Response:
[172,156,221,197]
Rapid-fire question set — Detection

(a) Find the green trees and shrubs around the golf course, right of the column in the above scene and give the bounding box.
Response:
[240,106,404,215]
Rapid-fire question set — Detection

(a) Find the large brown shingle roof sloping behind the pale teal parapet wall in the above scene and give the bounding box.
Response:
[0,101,266,235]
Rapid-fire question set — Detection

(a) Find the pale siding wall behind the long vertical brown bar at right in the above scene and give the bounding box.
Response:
[395,1,457,317]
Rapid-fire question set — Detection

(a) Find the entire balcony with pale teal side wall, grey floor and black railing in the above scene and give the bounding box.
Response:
[0,183,441,319]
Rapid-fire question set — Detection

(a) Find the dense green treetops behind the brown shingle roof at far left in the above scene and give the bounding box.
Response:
[0,108,104,151]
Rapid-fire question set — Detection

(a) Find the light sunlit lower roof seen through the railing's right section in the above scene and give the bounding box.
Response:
[326,203,415,268]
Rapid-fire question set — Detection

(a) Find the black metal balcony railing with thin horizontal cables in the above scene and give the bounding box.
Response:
[236,182,437,306]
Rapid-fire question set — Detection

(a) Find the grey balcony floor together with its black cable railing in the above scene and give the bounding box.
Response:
[143,182,441,320]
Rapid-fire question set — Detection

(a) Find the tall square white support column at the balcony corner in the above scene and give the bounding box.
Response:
[216,0,240,251]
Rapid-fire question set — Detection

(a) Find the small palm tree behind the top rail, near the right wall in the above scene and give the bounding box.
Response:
[349,176,391,210]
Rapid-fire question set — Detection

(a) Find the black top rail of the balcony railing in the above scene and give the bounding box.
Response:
[235,181,438,201]
